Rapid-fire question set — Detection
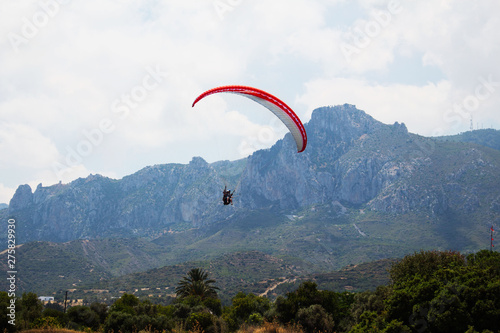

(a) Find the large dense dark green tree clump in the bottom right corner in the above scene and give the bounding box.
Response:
[384,251,500,333]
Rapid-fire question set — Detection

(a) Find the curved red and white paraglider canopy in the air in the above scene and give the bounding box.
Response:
[193,86,307,153]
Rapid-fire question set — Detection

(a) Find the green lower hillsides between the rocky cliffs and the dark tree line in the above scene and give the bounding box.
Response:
[3,202,489,295]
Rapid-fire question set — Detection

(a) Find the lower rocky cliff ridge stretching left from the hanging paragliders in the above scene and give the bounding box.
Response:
[8,158,238,242]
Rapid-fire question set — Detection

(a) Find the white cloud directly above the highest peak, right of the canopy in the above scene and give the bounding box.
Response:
[298,79,450,135]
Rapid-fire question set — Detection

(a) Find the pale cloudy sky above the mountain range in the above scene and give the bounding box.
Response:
[0,0,500,203]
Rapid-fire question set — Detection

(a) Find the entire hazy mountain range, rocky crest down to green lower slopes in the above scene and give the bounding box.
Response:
[0,104,500,298]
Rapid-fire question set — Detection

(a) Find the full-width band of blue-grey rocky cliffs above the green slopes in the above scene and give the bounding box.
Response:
[0,104,500,242]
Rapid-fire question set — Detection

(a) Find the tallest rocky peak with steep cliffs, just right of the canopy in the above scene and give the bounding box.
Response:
[242,105,410,209]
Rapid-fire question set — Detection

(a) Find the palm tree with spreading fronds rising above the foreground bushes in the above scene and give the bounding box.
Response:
[175,268,219,299]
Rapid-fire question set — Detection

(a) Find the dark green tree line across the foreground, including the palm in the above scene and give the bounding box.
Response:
[0,250,500,333]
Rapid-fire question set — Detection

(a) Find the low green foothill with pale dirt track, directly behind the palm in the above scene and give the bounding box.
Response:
[48,251,393,304]
